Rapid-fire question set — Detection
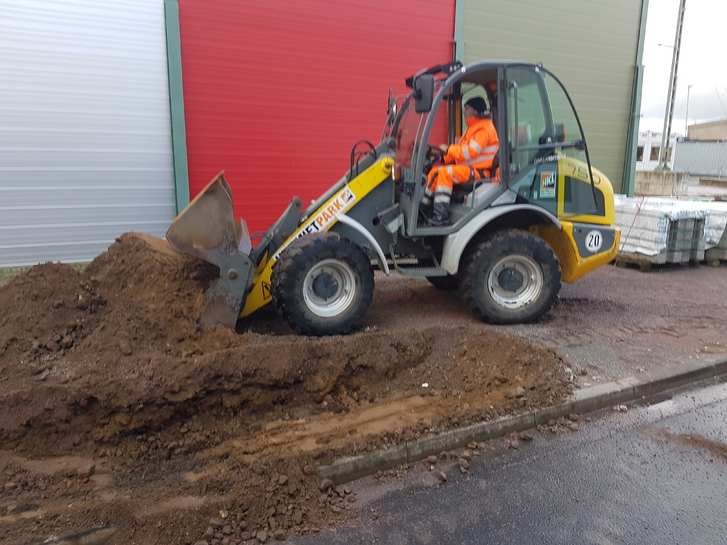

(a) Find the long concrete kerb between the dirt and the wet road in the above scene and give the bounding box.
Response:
[316,356,727,485]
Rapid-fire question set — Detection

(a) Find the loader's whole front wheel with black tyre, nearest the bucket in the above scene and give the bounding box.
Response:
[271,233,374,336]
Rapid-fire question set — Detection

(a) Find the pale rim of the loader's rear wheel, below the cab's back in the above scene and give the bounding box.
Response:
[487,255,544,309]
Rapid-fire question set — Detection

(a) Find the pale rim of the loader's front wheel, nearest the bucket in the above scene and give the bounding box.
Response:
[303,259,356,318]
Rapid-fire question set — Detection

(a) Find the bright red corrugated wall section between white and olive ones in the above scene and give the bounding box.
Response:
[179,0,455,233]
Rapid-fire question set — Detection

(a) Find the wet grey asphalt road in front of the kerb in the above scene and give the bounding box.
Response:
[293,383,727,545]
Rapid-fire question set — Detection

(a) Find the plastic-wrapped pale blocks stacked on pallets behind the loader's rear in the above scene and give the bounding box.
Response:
[615,195,727,266]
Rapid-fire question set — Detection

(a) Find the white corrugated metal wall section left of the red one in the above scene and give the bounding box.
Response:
[0,0,176,267]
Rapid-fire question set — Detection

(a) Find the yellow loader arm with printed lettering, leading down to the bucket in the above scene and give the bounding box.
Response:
[240,157,394,318]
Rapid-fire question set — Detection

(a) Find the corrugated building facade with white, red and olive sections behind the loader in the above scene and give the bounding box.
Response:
[0,0,647,267]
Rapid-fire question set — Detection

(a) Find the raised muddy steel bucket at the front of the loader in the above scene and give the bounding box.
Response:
[167,172,254,328]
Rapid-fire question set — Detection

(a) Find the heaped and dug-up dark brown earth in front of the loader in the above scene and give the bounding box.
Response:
[0,233,573,545]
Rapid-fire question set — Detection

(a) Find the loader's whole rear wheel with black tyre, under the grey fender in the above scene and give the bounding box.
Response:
[460,230,561,324]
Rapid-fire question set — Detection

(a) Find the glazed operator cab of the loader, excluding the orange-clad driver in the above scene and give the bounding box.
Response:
[384,62,609,235]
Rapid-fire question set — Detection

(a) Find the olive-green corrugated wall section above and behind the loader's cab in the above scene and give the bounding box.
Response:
[460,0,642,191]
